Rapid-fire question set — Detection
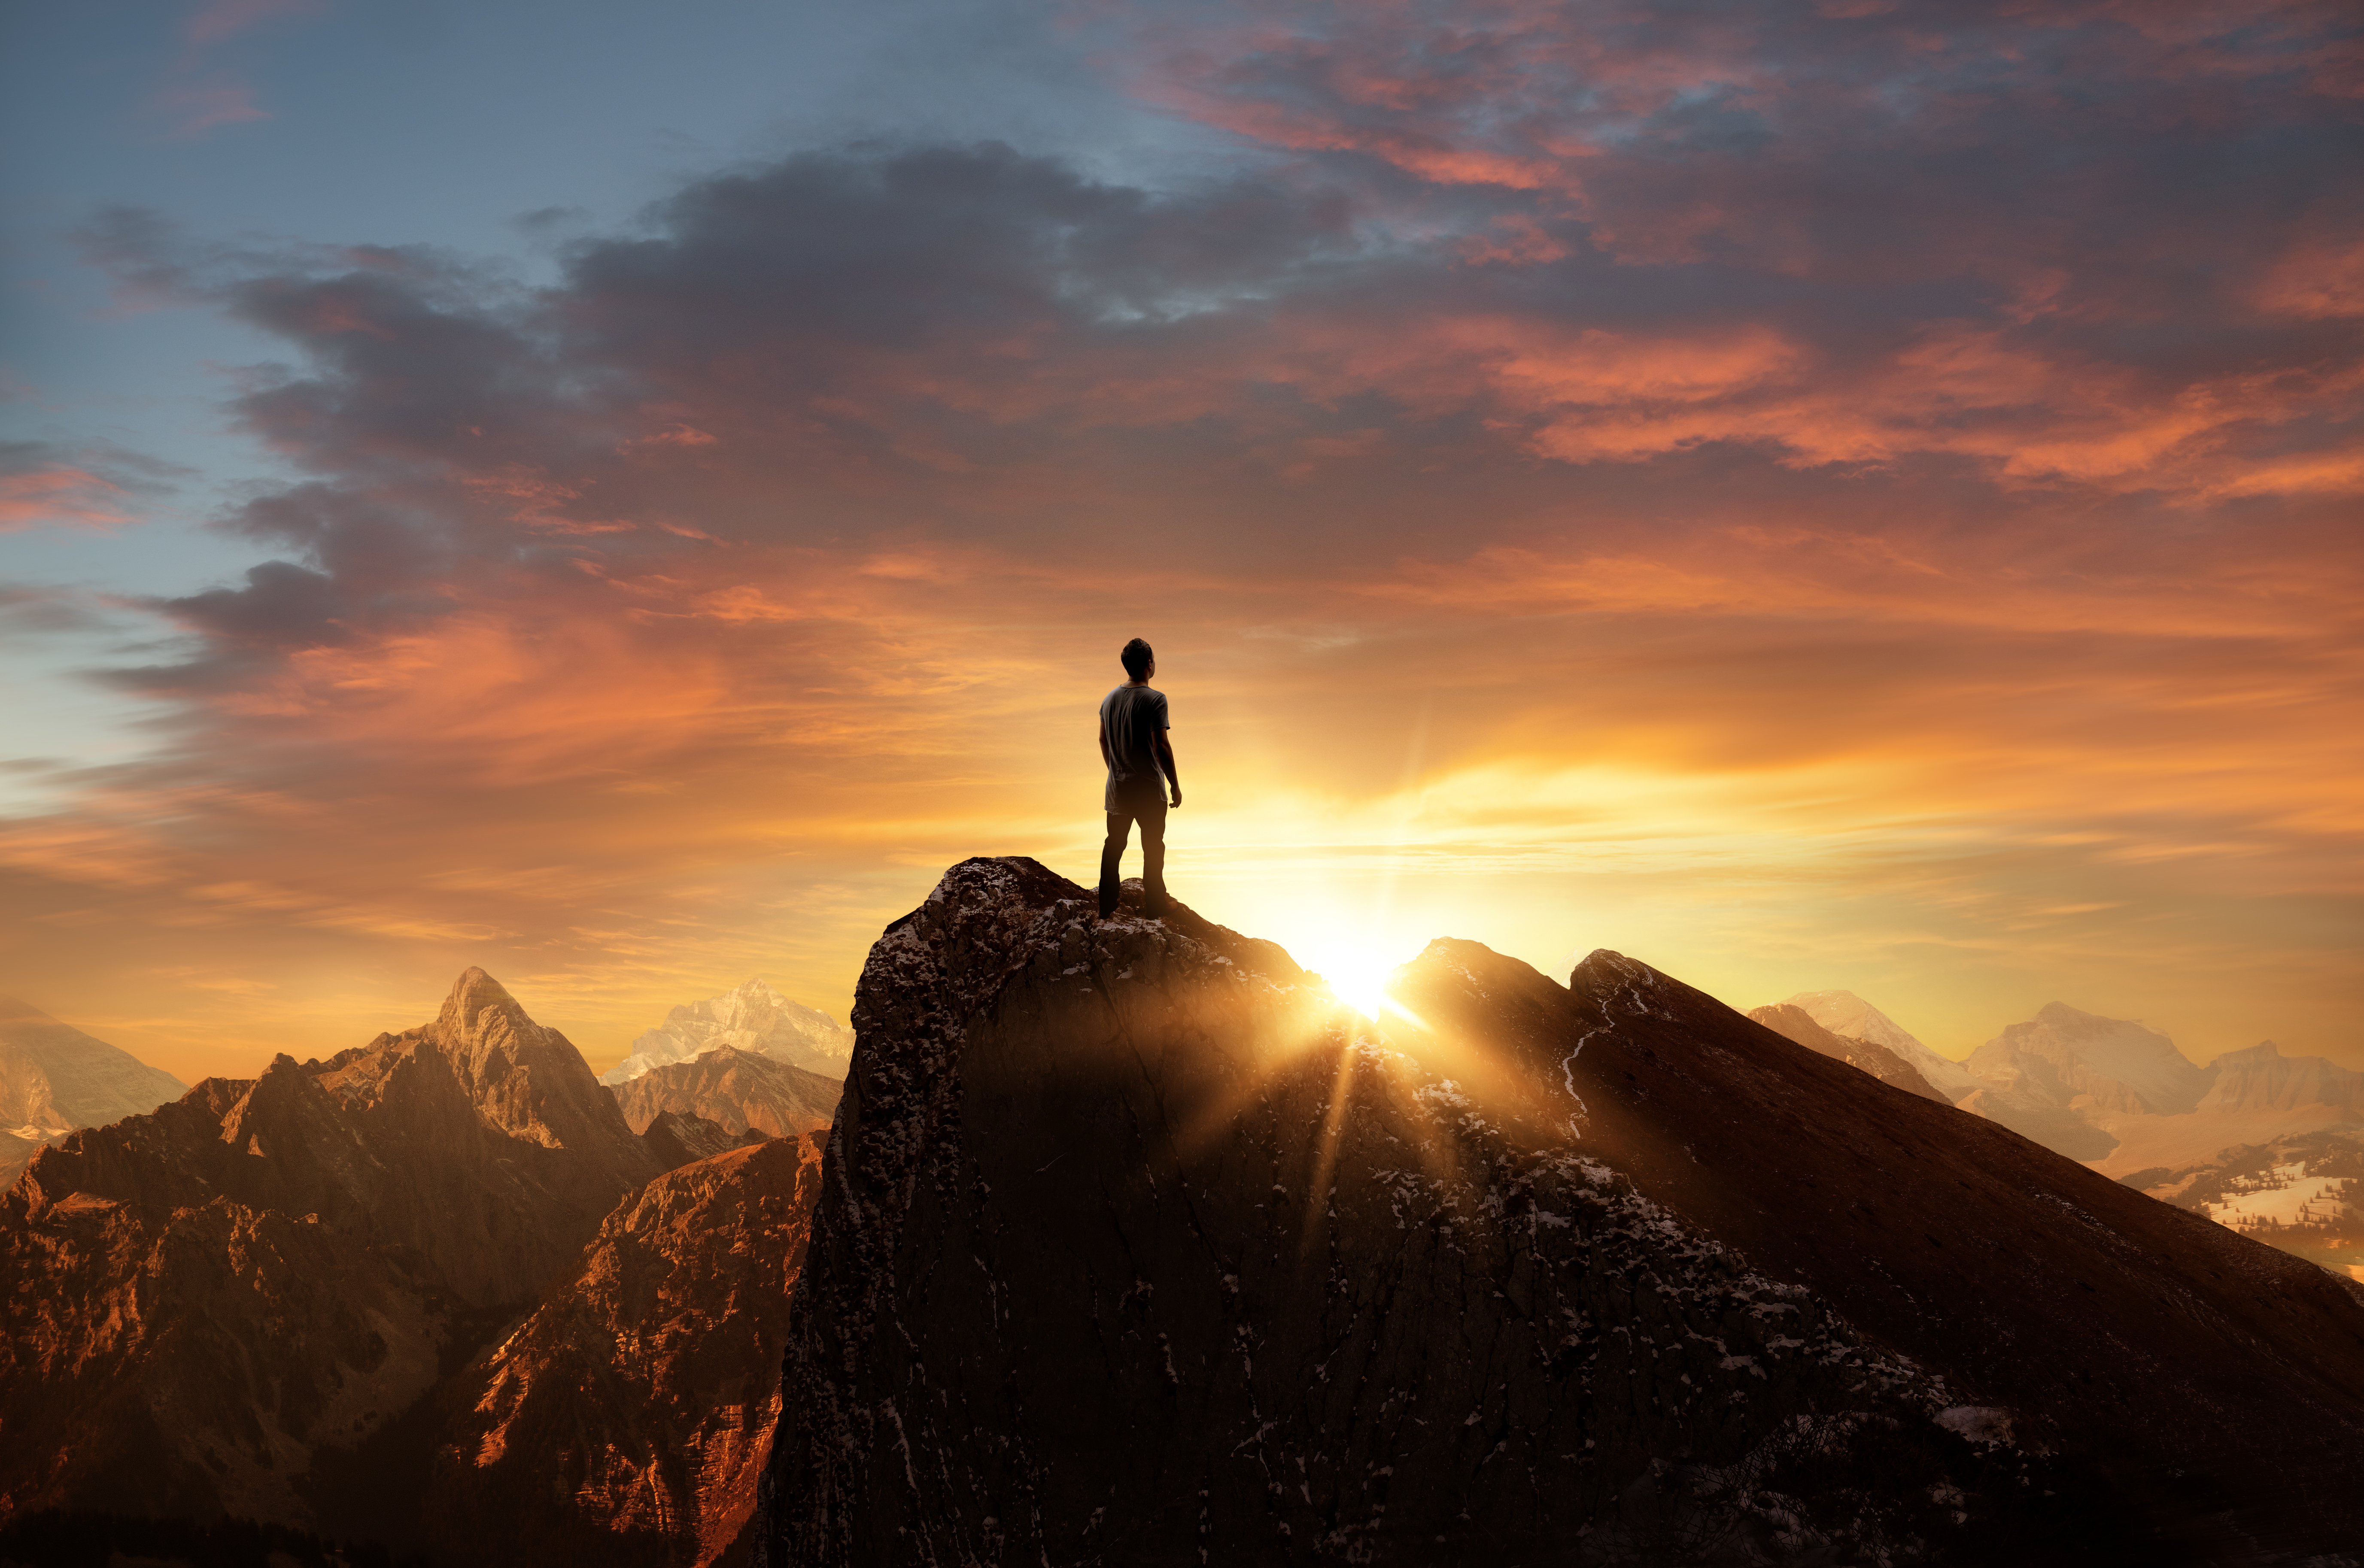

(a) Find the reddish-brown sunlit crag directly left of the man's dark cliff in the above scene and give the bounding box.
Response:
[423,1137,820,1568]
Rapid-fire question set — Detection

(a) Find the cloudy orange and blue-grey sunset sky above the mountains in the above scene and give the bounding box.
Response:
[0,0,2364,1081]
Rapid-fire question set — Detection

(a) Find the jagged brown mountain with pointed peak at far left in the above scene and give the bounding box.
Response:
[0,970,659,1526]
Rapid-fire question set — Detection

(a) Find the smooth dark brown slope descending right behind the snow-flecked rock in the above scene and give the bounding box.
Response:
[1400,941,2364,1561]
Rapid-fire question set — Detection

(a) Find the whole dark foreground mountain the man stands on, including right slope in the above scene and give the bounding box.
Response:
[761,861,2364,1565]
